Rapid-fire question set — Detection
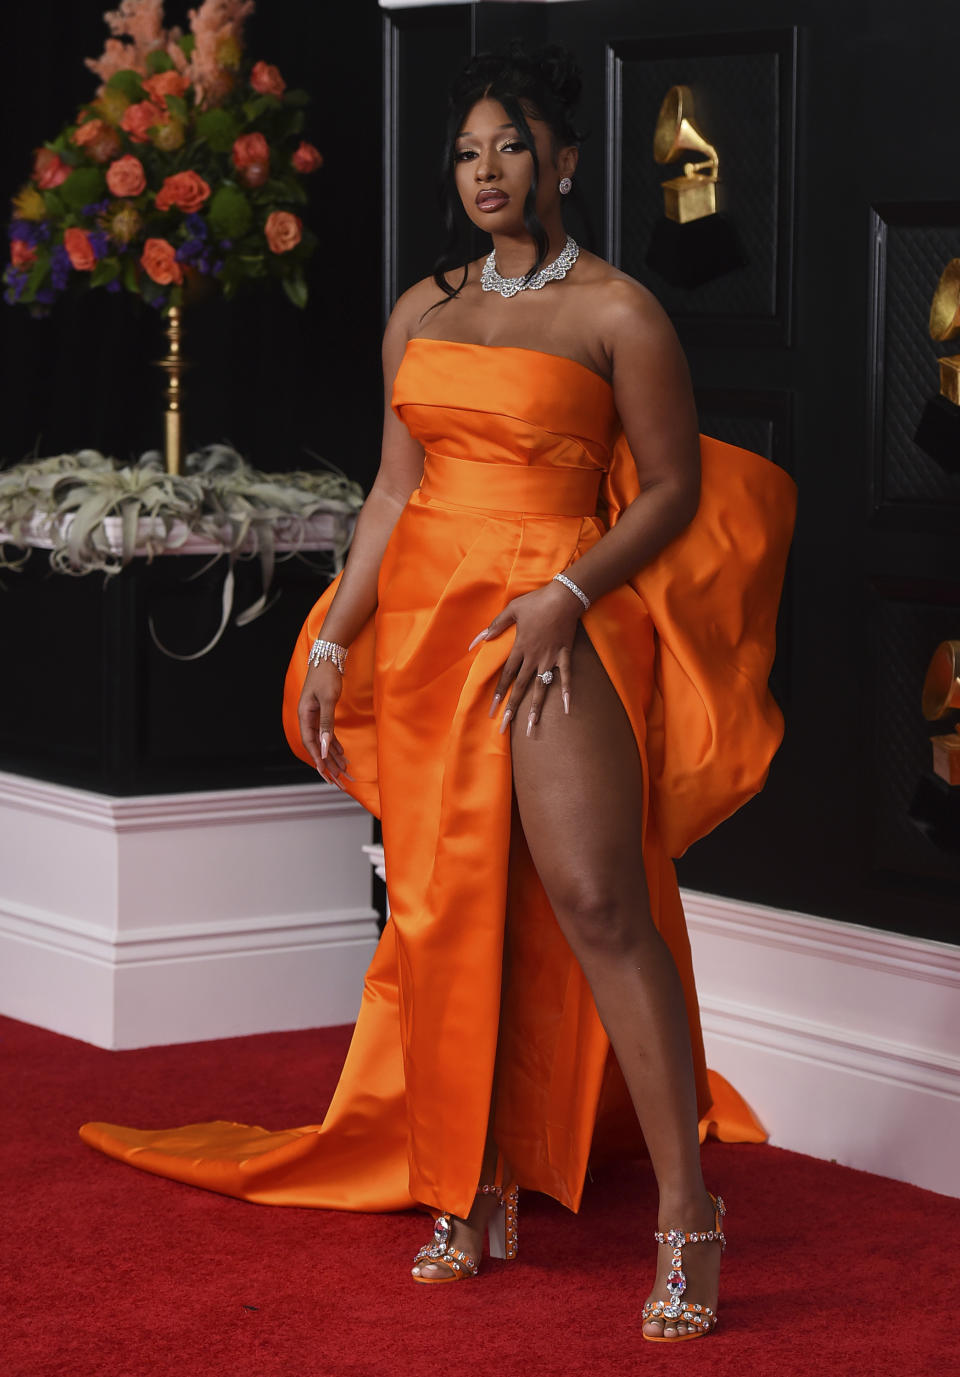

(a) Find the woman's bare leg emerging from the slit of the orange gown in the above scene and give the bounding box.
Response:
[511,628,720,1337]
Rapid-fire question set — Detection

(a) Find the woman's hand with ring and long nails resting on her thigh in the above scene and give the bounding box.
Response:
[470,581,581,737]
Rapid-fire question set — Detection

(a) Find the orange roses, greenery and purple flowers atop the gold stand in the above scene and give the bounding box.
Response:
[3,0,322,315]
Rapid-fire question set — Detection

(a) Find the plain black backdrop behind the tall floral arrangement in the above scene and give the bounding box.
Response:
[0,0,382,483]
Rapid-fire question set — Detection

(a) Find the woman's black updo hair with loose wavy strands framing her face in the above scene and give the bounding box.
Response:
[434,41,583,306]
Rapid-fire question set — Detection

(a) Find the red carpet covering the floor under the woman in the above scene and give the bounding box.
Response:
[0,1019,960,1377]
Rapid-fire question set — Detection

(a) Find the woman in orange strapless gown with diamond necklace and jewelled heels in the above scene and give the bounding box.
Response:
[81,55,795,1341]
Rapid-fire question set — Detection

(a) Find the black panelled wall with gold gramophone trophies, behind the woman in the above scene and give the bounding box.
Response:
[384,0,960,942]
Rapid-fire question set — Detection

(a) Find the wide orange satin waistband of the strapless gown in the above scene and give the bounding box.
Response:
[420,450,603,516]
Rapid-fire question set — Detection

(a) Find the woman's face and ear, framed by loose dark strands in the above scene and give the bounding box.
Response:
[453,99,577,234]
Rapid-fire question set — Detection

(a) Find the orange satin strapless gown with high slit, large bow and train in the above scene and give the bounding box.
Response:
[80,339,795,1216]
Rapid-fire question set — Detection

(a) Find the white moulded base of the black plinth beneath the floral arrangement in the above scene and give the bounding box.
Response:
[0,772,377,1048]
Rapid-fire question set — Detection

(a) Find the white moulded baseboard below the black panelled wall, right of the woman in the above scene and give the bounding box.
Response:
[683,890,960,1195]
